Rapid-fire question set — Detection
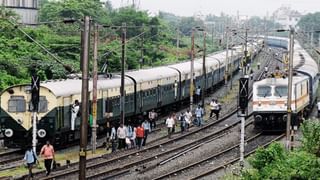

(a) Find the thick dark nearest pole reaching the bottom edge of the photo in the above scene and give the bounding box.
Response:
[79,16,90,180]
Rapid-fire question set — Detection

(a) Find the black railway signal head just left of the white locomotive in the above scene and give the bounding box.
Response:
[239,77,249,114]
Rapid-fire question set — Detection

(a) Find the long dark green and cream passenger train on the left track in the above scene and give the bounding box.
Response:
[0,40,262,147]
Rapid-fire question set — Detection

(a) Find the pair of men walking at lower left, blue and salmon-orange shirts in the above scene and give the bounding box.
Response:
[24,141,55,179]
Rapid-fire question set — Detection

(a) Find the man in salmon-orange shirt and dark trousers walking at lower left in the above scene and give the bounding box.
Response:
[40,141,54,176]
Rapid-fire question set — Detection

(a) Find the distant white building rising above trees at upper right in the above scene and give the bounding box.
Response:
[273,6,302,29]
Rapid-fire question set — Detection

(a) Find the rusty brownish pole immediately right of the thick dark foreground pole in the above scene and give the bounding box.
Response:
[91,25,99,154]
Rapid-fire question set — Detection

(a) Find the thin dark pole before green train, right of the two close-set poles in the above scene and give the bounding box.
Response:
[120,23,127,124]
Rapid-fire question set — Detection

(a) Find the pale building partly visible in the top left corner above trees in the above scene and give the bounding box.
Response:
[0,0,39,25]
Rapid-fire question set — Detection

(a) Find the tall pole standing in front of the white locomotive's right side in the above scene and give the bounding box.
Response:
[286,27,295,150]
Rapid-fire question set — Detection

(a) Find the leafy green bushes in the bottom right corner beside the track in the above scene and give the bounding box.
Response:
[231,119,320,180]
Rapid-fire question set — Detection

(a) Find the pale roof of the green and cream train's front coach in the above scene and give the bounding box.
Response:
[40,76,133,97]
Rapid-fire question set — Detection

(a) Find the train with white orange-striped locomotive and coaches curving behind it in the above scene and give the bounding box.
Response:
[252,37,319,131]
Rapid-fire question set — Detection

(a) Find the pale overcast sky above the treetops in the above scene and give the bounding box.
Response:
[105,0,320,16]
